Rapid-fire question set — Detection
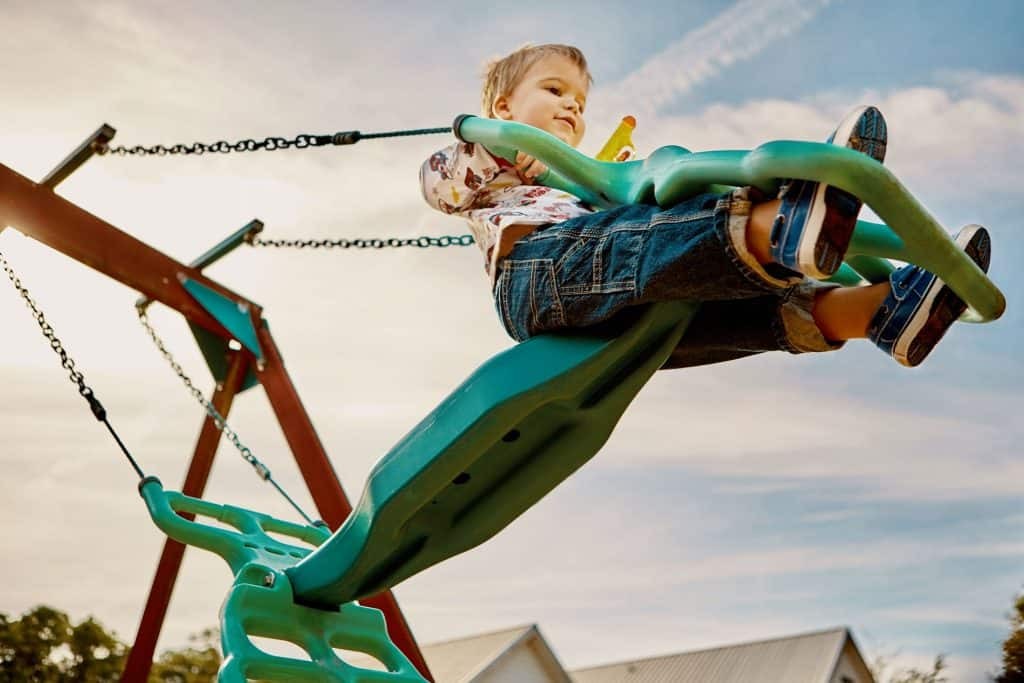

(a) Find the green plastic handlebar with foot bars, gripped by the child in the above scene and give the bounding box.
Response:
[455,117,1006,323]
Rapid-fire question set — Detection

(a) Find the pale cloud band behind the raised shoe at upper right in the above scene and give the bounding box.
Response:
[618,74,1024,198]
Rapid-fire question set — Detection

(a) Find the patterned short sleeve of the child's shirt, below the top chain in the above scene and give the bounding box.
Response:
[420,142,502,213]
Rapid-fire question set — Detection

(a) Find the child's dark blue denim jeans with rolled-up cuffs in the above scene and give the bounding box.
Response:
[494,187,842,368]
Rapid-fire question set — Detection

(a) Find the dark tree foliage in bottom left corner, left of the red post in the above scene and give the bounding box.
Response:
[0,605,128,683]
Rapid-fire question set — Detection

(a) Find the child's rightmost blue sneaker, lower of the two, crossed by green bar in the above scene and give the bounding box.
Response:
[867,225,992,368]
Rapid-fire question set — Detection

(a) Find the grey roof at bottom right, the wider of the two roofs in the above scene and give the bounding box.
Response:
[570,628,866,683]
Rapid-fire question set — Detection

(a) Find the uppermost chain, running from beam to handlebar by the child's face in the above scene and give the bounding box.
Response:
[97,126,452,157]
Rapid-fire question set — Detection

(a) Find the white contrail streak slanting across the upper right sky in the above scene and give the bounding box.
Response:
[602,0,830,114]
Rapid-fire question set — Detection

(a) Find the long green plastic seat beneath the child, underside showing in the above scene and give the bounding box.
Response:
[286,301,697,607]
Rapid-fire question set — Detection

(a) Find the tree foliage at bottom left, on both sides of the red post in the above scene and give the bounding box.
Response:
[0,605,220,683]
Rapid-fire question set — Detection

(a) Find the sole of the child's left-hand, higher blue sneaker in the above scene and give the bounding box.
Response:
[797,106,888,280]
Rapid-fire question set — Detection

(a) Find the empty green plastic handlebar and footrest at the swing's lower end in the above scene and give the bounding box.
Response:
[139,477,425,683]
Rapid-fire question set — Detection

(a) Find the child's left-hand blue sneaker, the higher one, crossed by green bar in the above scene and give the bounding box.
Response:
[771,106,888,280]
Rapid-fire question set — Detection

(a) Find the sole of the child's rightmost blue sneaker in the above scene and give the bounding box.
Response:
[893,225,992,368]
